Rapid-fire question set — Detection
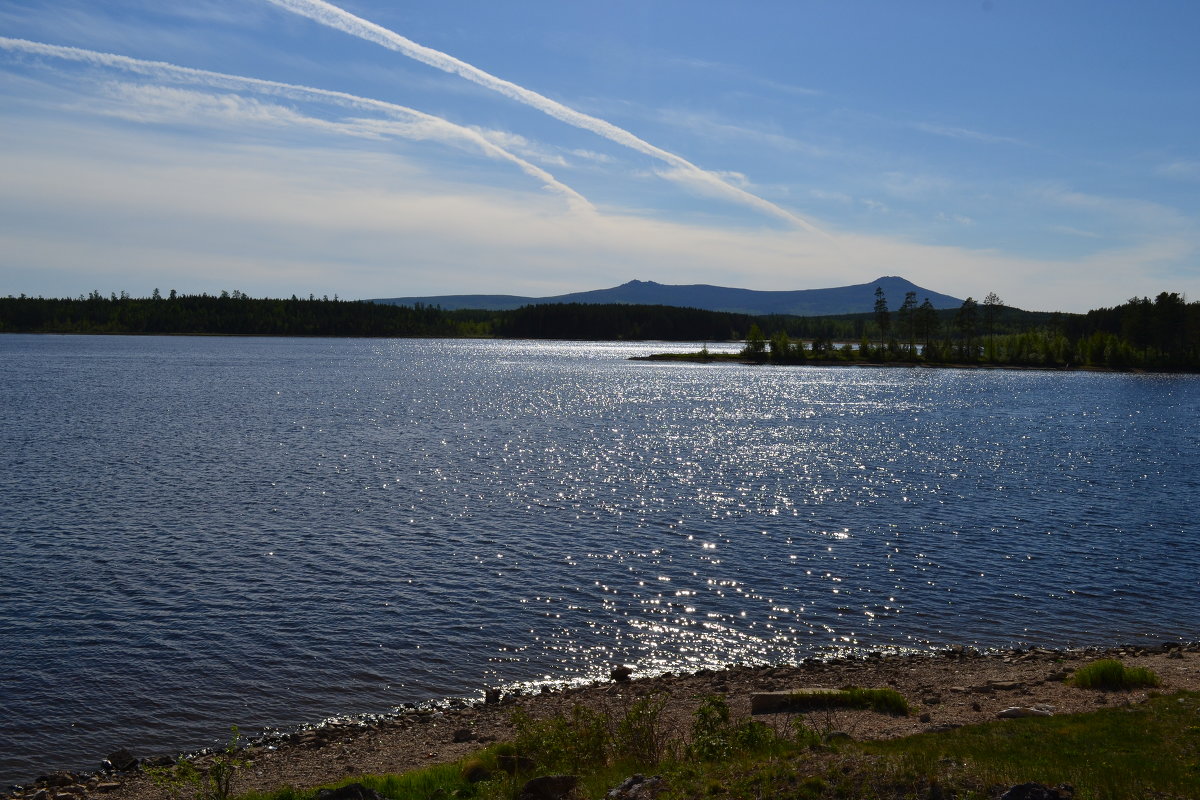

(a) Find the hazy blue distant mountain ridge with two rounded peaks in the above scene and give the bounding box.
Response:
[372,277,962,317]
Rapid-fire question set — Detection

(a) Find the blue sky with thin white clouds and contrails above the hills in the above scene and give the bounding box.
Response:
[0,0,1200,311]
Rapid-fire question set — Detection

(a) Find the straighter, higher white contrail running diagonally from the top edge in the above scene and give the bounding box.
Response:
[262,0,824,234]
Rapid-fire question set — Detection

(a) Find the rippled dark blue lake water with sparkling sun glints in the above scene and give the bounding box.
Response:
[0,336,1200,784]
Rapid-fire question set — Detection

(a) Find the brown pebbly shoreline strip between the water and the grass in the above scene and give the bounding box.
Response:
[11,642,1200,800]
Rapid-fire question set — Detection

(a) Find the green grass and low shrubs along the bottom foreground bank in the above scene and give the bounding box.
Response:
[220,692,1200,800]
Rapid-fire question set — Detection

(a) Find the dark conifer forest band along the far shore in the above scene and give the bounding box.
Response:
[0,289,1200,372]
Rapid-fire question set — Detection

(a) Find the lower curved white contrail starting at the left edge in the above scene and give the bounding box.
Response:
[0,36,595,211]
